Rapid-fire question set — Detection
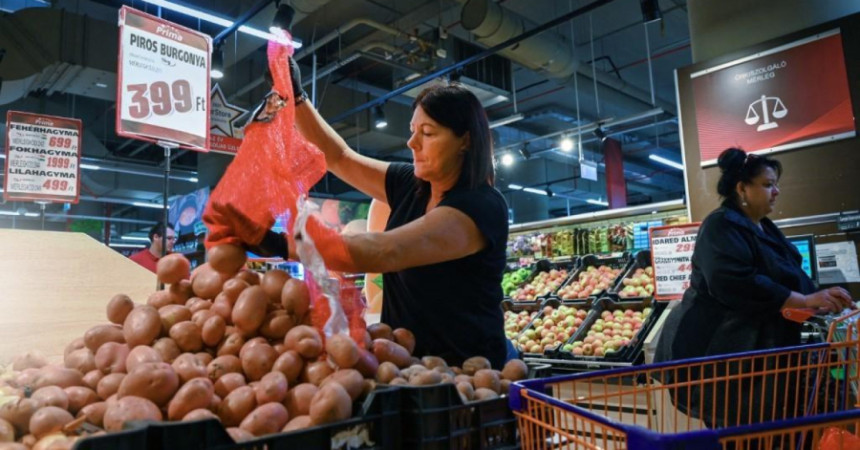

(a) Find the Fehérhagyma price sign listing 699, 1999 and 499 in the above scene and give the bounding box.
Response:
[3,111,82,203]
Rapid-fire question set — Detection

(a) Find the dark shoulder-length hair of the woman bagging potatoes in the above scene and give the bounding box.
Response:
[412,83,496,191]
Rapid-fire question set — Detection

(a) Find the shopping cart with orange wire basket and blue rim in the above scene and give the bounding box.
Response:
[510,311,860,450]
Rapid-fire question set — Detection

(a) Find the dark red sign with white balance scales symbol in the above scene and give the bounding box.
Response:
[690,29,856,166]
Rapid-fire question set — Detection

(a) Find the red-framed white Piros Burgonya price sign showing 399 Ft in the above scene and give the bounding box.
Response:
[116,6,212,151]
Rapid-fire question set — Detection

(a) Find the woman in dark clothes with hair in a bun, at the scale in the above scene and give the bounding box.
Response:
[655,148,853,426]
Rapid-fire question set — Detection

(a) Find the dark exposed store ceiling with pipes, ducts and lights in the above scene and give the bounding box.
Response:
[0,0,691,239]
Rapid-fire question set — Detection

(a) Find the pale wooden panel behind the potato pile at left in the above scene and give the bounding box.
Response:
[0,229,156,365]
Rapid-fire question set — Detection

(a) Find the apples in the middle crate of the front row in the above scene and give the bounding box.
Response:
[513,299,592,358]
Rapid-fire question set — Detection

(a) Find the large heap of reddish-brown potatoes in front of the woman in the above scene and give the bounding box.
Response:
[0,246,527,450]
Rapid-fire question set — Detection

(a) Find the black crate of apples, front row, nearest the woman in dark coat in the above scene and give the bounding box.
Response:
[557,297,666,365]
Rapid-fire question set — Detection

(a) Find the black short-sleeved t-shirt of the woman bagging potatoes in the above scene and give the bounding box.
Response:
[382,163,508,369]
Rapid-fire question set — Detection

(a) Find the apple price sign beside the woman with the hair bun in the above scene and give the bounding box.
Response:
[650,222,701,300]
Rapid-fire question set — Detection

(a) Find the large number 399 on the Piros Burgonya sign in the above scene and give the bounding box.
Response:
[125,80,193,119]
